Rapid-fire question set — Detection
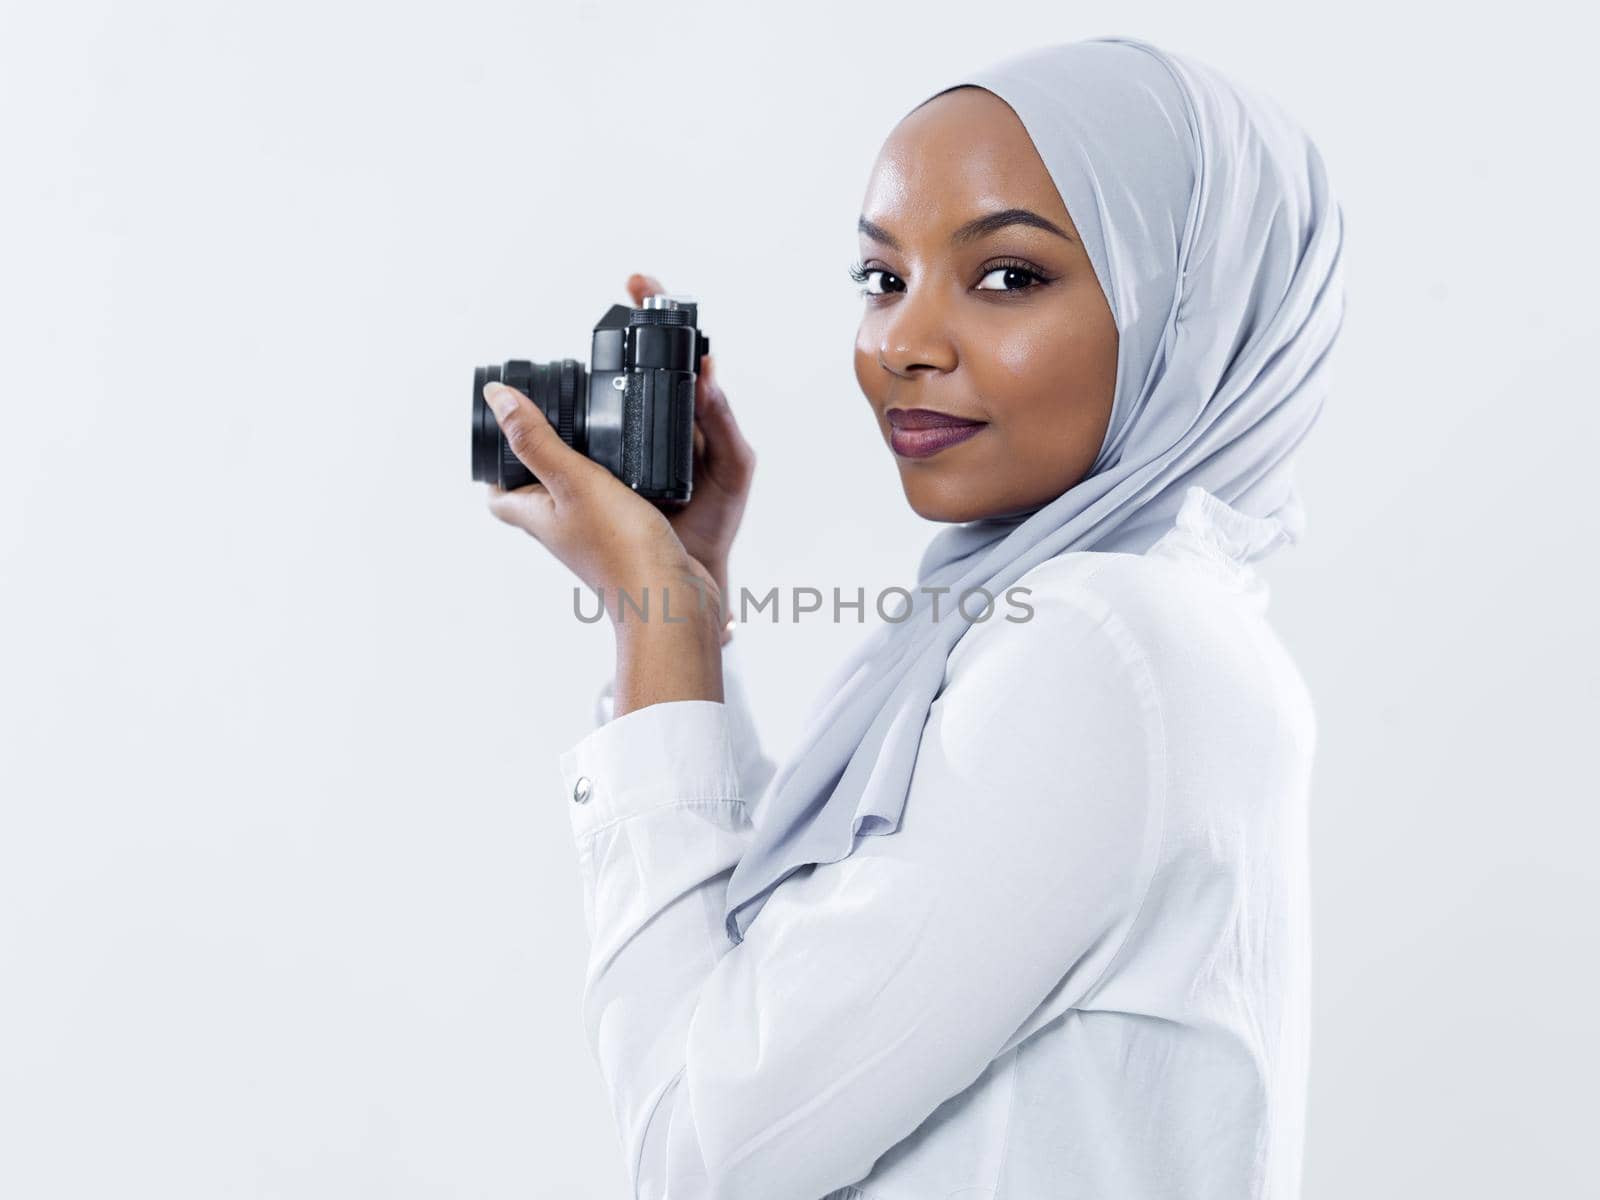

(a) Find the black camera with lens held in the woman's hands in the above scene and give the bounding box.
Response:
[472,296,710,501]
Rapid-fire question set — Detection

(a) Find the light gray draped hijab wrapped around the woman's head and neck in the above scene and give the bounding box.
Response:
[725,37,1344,942]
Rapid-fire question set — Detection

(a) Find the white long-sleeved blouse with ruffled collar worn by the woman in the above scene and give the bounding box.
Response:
[560,488,1314,1200]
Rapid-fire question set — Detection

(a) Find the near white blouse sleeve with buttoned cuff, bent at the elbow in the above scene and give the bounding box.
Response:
[562,592,1163,1200]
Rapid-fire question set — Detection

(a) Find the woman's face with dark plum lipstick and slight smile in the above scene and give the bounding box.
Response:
[856,86,1117,522]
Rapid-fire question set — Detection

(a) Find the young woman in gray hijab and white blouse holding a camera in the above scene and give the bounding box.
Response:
[488,38,1344,1200]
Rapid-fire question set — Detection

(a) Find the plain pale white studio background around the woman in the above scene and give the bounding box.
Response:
[0,0,1600,1200]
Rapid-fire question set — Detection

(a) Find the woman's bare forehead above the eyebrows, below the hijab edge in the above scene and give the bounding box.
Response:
[861,88,1067,226]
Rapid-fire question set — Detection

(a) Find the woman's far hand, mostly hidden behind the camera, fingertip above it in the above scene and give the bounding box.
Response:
[627,275,755,606]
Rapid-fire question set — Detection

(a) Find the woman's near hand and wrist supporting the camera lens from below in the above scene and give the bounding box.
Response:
[483,384,723,717]
